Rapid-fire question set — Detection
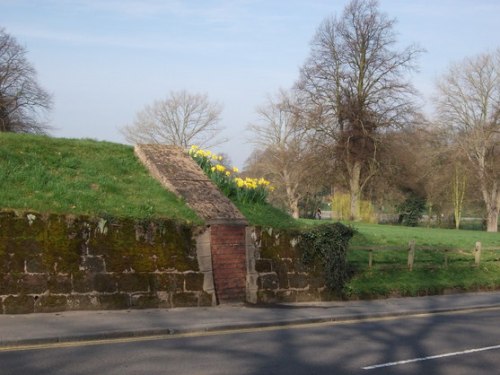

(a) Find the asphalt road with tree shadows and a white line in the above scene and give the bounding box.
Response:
[0,309,500,375]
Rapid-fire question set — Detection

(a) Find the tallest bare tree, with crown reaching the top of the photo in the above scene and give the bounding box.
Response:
[298,0,421,219]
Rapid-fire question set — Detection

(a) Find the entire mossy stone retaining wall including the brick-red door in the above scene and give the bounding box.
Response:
[0,212,336,314]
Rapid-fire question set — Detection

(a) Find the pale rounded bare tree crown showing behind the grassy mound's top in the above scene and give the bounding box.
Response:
[121,91,226,148]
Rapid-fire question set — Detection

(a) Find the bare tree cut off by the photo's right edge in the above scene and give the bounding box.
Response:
[437,49,500,232]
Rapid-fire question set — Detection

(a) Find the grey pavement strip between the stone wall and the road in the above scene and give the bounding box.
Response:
[0,292,500,348]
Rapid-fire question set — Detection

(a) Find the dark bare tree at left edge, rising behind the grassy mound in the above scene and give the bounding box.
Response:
[0,28,52,134]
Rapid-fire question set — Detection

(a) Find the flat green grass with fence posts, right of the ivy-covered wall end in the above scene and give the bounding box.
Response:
[348,223,500,298]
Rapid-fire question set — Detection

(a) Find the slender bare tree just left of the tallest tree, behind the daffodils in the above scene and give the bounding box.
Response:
[248,90,315,218]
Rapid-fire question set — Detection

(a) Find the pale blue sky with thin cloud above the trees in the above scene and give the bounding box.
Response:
[0,0,500,168]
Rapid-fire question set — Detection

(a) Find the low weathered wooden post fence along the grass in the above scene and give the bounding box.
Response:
[349,241,500,271]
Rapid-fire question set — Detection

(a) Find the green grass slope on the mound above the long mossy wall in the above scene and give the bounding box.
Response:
[0,133,202,223]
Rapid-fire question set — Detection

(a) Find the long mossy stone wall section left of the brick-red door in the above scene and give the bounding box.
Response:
[0,212,215,314]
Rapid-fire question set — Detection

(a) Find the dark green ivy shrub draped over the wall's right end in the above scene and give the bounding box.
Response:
[300,223,354,298]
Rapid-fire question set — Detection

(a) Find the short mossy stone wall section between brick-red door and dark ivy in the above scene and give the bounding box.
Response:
[247,228,332,303]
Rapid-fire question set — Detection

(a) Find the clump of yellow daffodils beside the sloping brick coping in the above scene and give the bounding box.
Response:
[189,146,273,203]
